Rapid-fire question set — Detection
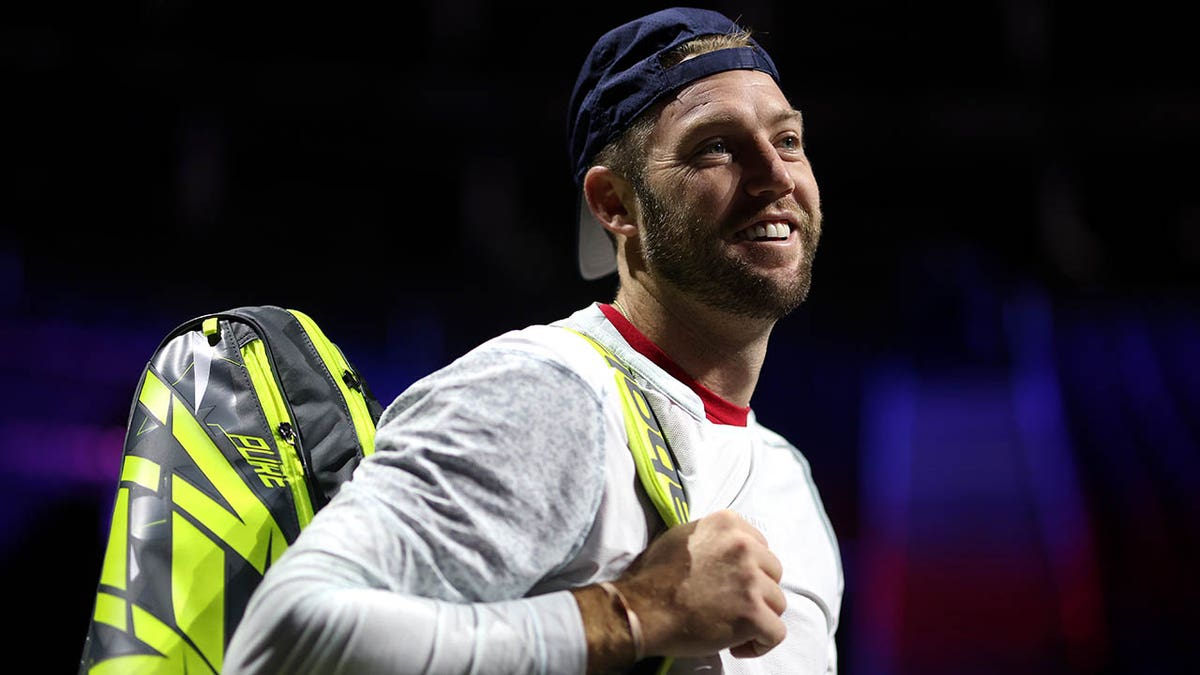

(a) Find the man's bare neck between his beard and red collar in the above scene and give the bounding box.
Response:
[614,283,774,406]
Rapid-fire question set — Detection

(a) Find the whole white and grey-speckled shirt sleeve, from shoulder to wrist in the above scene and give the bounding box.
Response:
[223,348,605,674]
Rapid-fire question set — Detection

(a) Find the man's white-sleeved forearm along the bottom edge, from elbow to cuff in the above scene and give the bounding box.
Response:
[223,580,584,675]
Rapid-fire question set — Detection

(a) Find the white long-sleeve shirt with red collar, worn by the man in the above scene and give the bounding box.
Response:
[223,305,844,675]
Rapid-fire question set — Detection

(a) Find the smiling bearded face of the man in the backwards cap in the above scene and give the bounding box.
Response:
[634,71,821,319]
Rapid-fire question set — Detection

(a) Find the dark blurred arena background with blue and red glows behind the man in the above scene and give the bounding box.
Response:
[0,0,1200,675]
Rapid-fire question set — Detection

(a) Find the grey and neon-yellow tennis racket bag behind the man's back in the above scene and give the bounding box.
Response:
[79,305,383,675]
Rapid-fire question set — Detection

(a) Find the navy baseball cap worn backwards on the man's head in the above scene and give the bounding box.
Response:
[568,7,779,280]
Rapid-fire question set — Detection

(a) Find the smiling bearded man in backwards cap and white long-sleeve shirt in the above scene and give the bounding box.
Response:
[226,8,842,674]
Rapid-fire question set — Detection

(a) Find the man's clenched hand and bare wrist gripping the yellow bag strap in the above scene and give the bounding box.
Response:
[576,510,787,671]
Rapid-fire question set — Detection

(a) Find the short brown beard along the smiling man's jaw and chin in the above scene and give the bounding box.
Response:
[635,174,821,321]
